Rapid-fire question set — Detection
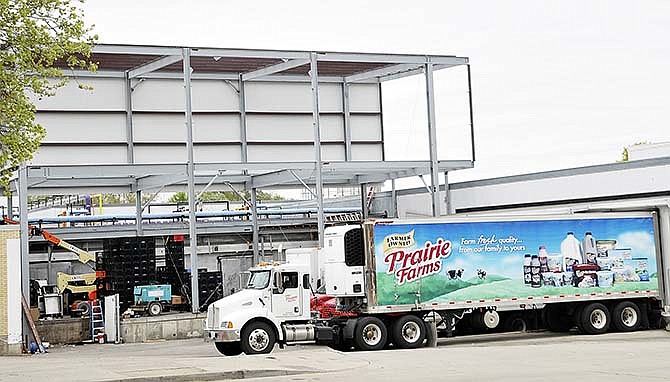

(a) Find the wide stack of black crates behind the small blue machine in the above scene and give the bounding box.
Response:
[97,237,156,310]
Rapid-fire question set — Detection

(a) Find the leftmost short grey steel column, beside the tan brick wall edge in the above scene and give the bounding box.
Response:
[19,162,31,344]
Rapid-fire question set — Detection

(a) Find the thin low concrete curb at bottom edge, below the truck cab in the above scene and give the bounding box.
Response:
[101,370,315,382]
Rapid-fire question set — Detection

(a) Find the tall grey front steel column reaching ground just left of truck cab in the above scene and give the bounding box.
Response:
[182,48,200,313]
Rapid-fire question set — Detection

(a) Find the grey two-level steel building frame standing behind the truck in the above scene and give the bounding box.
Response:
[10,45,475,318]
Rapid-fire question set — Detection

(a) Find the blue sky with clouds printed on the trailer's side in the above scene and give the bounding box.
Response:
[374,218,656,280]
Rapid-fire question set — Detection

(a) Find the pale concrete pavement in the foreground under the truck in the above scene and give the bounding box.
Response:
[0,330,670,382]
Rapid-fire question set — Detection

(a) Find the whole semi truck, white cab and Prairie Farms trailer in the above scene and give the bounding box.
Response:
[204,211,670,356]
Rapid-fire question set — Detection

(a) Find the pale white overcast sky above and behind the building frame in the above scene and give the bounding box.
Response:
[84,0,670,182]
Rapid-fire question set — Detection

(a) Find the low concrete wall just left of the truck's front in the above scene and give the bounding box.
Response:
[121,313,207,343]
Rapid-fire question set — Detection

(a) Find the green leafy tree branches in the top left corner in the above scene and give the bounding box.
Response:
[0,0,98,190]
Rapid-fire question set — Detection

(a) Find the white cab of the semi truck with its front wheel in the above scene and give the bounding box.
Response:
[205,263,314,355]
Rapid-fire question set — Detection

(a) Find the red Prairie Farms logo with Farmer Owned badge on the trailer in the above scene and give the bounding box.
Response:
[383,230,451,285]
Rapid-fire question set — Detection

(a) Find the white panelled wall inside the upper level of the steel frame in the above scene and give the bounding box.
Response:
[32,78,383,165]
